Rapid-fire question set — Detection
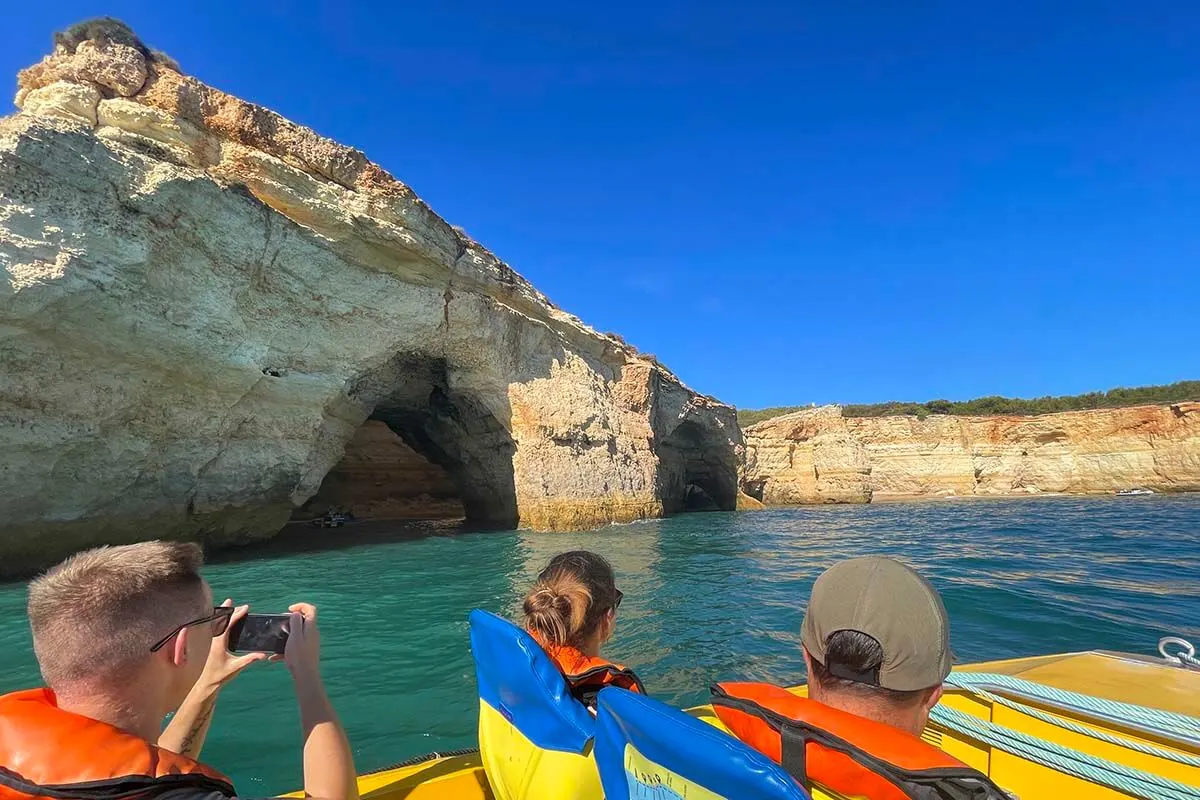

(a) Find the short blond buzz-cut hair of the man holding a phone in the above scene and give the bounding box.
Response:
[29,541,211,692]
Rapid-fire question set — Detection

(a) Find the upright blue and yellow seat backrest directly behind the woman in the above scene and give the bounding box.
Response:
[470,609,602,800]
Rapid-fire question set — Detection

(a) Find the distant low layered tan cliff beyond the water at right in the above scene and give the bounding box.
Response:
[743,403,1200,505]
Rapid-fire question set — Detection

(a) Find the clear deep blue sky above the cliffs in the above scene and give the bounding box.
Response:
[0,0,1200,408]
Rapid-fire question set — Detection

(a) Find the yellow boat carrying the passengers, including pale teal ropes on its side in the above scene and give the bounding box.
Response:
[293,651,1200,800]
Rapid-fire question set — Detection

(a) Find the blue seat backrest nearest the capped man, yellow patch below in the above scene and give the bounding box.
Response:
[595,688,809,800]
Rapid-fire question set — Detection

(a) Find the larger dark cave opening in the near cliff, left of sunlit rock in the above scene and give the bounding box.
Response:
[298,356,517,530]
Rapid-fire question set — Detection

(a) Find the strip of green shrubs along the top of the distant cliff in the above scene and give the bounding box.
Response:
[738,380,1200,428]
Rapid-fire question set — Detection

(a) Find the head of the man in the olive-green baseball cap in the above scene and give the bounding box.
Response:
[800,557,954,736]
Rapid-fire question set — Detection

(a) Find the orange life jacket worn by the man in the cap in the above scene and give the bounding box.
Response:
[712,684,1008,800]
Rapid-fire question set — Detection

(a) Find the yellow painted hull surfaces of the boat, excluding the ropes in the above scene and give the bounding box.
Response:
[300,652,1200,800]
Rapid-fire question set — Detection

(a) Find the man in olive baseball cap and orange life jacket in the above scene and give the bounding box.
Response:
[713,557,1009,800]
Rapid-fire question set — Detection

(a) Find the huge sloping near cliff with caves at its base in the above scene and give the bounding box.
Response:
[0,25,740,573]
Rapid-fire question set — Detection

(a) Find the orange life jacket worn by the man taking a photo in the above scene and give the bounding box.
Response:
[0,688,234,800]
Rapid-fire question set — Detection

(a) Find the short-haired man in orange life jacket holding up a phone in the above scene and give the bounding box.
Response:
[0,541,358,800]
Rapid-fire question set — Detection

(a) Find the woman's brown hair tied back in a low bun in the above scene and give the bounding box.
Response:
[524,551,618,648]
